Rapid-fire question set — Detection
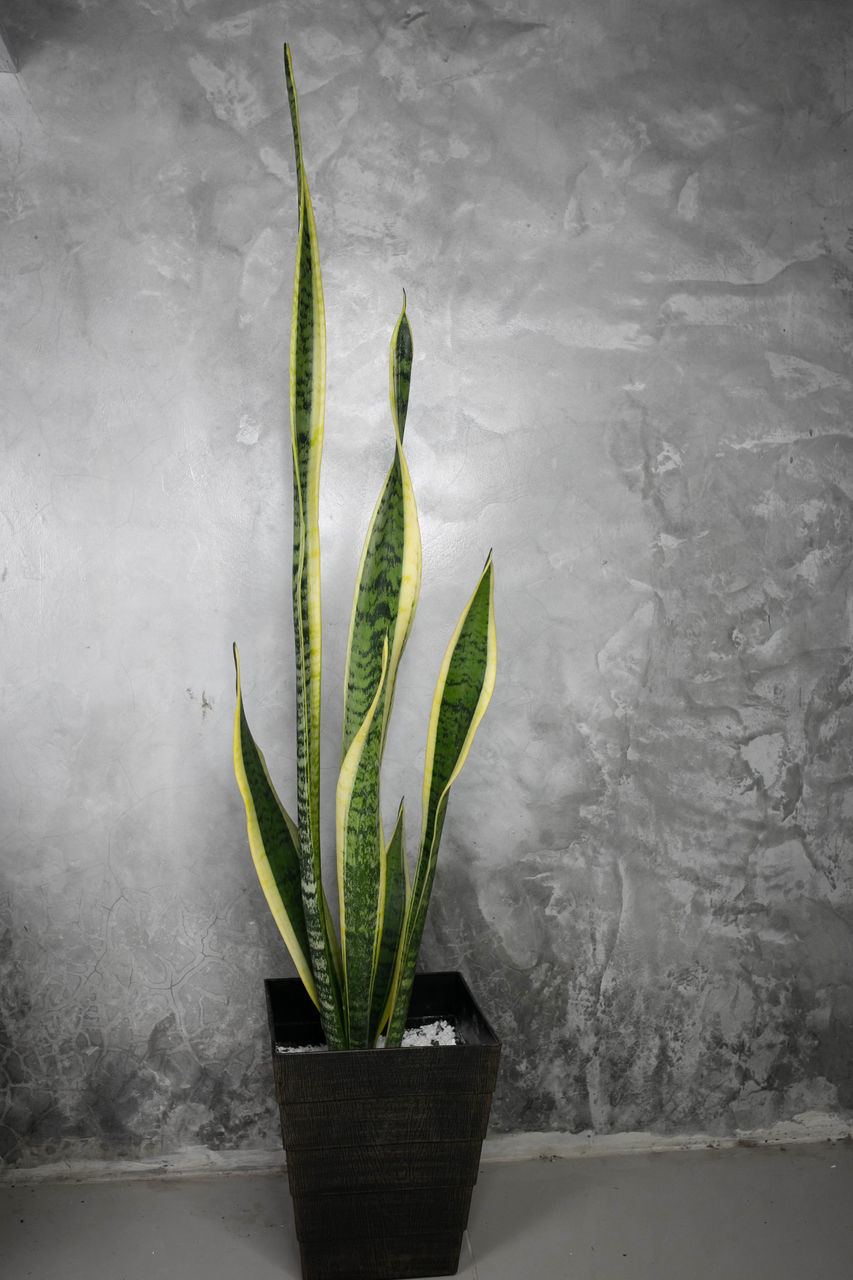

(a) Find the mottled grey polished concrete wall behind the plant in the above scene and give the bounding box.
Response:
[0,0,853,1164]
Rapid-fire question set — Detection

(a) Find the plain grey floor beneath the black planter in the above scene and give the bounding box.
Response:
[0,1142,853,1280]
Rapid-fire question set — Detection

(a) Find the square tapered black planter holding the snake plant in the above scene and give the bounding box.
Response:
[264,973,501,1280]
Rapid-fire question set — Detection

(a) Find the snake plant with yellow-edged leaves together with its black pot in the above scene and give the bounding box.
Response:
[234,46,500,1280]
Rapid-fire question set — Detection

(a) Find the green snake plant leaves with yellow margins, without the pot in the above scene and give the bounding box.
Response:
[234,45,496,1048]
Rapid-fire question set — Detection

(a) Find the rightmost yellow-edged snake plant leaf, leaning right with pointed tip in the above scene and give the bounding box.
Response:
[387,554,497,1044]
